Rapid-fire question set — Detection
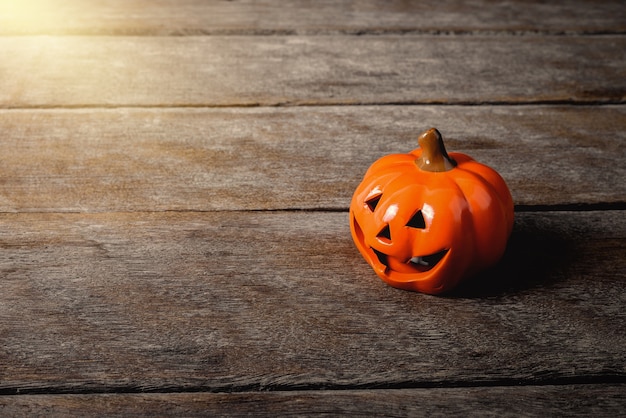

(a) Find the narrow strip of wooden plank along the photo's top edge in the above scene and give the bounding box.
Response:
[0,0,626,35]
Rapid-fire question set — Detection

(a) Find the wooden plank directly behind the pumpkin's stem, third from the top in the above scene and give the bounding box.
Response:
[0,106,626,212]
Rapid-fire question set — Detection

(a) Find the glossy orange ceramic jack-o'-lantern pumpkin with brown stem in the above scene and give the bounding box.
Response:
[350,129,513,294]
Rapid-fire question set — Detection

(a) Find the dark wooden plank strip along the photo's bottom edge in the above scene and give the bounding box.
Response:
[0,385,626,417]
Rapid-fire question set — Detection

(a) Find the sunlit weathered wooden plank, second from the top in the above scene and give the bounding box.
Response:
[0,36,626,108]
